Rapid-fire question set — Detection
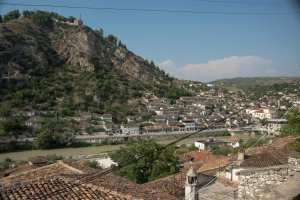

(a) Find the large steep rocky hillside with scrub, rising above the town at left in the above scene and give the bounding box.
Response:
[0,11,188,120]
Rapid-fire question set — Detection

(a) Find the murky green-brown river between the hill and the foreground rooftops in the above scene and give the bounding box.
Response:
[0,136,249,162]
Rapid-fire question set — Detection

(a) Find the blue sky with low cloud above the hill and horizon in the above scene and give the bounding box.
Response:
[0,0,300,82]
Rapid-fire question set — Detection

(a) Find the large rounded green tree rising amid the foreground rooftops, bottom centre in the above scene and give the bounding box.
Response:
[111,141,178,183]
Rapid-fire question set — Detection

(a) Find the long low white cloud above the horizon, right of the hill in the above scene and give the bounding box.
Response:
[158,56,276,81]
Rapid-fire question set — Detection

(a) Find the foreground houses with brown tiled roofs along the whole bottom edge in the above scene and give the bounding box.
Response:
[0,137,300,200]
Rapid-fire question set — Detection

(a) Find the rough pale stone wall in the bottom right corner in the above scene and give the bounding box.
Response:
[237,158,300,199]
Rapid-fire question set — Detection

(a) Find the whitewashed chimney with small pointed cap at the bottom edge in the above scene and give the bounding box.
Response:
[184,167,198,200]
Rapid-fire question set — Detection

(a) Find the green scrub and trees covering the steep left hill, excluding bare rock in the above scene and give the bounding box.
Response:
[0,10,190,149]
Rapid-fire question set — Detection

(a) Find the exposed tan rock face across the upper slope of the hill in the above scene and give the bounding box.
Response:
[0,18,165,82]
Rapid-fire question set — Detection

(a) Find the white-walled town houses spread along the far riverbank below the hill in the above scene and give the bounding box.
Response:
[2,79,300,138]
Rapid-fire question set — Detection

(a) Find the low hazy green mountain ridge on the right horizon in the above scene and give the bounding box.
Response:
[210,77,300,88]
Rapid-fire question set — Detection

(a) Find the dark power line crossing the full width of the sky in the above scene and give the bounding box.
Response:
[0,2,299,15]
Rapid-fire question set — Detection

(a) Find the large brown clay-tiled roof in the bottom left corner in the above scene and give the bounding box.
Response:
[0,160,176,200]
